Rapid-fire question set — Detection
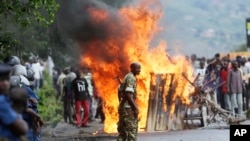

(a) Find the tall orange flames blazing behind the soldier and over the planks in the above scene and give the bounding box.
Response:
[79,0,192,133]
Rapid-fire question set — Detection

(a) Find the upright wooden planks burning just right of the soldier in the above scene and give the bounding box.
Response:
[146,74,184,131]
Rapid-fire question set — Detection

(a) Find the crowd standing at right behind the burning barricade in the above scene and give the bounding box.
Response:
[191,53,250,117]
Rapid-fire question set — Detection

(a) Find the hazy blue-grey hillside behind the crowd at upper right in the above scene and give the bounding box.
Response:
[158,0,250,57]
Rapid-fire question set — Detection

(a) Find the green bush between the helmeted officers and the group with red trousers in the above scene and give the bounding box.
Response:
[38,72,62,126]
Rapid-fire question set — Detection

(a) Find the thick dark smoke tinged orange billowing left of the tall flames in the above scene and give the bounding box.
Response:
[58,0,135,67]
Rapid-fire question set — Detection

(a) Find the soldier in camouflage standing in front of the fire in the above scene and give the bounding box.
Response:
[117,62,141,141]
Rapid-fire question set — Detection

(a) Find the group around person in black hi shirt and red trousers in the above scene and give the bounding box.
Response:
[53,66,105,128]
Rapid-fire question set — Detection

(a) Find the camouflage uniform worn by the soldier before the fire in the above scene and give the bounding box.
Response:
[117,72,138,141]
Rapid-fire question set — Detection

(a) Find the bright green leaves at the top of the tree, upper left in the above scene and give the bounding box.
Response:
[0,0,59,27]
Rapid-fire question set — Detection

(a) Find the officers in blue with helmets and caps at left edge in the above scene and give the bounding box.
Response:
[0,56,43,141]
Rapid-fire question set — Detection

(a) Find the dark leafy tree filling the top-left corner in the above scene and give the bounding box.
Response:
[0,0,59,59]
